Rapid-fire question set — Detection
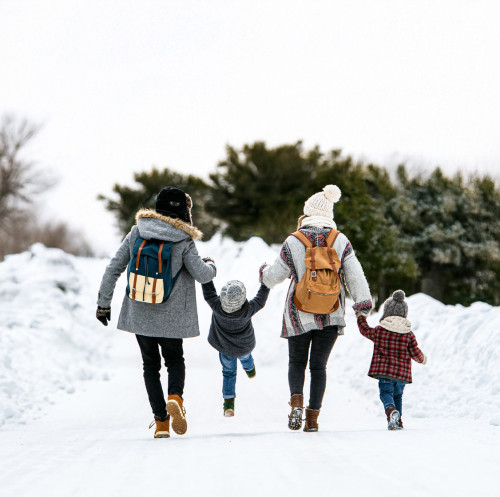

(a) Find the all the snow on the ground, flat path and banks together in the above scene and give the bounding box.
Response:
[0,238,500,497]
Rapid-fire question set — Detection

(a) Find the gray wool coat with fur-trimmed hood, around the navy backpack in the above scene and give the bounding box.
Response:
[97,209,215,338]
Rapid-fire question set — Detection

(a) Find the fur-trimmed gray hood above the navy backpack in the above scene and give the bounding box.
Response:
[135,209,203,242]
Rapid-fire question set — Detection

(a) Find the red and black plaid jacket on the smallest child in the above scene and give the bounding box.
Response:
[358,316,425,383]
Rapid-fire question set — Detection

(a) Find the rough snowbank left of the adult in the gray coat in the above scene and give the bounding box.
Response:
[0,245,111,426]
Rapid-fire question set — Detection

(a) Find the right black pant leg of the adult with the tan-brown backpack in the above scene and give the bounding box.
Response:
[309,326,338,409]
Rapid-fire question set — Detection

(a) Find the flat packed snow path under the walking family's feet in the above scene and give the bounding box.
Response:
[0,334,499,497]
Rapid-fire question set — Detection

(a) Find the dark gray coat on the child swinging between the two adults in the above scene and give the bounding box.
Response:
[201,282,269,357]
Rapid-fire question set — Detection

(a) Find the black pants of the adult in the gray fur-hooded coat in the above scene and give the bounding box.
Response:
[136,335,186,418]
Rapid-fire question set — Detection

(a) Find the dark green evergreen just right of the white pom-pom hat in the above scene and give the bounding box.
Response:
[315,150,417,304]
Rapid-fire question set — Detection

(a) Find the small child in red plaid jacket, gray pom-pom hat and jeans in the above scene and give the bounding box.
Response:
[357,290,427,430]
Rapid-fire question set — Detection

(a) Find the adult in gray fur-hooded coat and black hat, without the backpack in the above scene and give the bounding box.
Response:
[96,187,216,438]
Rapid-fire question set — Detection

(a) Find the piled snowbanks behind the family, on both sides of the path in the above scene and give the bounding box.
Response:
[0,237,500,425]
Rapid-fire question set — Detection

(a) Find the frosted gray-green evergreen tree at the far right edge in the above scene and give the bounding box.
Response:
[391,166,500,304]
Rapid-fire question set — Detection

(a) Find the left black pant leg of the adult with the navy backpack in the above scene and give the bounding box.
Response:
[136,335,167,418]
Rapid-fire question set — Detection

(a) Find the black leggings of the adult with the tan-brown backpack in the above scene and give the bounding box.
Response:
[288,326,338,409]
